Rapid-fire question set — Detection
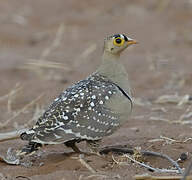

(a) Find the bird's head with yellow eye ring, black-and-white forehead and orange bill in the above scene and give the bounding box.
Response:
[104,34,137,55]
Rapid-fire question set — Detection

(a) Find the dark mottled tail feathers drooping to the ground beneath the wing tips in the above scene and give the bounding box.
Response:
[19,142,42,155]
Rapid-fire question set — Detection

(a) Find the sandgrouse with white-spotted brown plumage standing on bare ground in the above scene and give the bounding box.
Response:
[20,34,137,153]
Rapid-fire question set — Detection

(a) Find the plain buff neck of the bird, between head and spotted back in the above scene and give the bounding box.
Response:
[97,52,130,94]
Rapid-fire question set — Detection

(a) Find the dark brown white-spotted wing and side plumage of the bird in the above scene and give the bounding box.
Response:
[22,75,130,144]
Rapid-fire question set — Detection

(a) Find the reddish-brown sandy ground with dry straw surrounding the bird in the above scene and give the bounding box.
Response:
[0,0,192,180]
